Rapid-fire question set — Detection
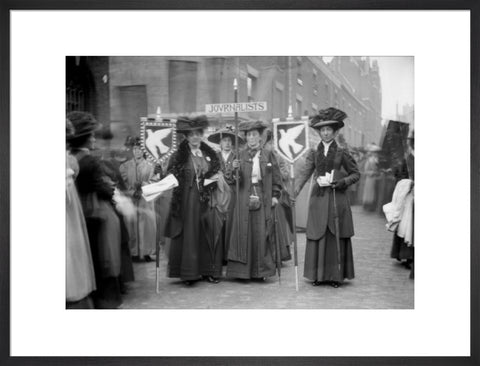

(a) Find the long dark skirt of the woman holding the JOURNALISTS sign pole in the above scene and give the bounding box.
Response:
[227,207,275,279]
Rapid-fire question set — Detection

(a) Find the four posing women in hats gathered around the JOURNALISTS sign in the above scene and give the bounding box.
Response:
[166,108,360,288]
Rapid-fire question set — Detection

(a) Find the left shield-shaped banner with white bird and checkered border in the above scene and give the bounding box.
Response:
[140,117,177,164]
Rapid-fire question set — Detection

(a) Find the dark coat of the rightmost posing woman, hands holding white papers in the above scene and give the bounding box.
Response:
[295,141,360,240]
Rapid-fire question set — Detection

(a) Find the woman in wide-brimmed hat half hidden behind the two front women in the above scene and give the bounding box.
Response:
[208,126,244,264]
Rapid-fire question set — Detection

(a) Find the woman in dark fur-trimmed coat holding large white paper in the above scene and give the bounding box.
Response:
[165,116,223,285]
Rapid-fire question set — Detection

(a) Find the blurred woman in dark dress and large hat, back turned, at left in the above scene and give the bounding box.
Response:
[67,112,121,308]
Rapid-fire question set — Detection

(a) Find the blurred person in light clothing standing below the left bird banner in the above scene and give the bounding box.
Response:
[119,137,157,262]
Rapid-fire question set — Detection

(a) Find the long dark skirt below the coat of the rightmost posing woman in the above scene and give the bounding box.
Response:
[303,230,355,282]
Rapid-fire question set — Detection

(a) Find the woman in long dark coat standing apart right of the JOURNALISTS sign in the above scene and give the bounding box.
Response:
[295,108,360,287]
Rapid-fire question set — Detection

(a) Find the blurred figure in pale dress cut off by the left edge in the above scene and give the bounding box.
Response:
[66,119,96,309]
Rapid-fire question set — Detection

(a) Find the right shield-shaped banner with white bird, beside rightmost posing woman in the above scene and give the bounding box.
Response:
[273,118,309,164]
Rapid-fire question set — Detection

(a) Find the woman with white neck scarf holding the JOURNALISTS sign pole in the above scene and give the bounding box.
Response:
[227,121,282,280]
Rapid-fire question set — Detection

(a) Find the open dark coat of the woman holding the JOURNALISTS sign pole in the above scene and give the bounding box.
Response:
[228,148,282,263]
